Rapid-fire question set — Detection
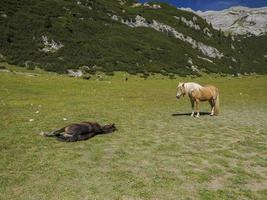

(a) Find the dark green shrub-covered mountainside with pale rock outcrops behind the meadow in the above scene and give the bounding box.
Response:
[0,0,267,75]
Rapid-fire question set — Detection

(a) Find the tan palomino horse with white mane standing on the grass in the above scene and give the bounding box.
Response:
[176,82,219,117]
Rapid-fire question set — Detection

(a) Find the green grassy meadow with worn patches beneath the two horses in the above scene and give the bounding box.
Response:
[0,68,267,200]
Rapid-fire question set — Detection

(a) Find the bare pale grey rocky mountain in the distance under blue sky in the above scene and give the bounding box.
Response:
[195,6,267,36]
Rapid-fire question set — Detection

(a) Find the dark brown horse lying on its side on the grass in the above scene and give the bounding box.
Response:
[41,122,117,142]
